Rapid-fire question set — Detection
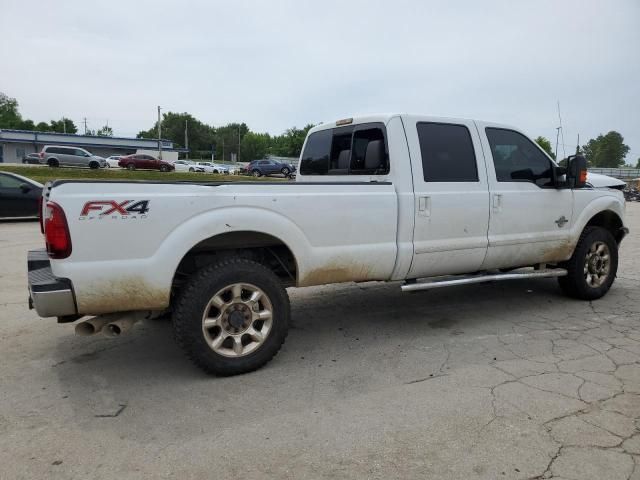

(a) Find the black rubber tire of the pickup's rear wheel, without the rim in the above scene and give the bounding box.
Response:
[173,257,291,376]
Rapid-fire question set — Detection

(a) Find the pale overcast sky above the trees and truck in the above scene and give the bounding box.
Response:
[0,0,640,161]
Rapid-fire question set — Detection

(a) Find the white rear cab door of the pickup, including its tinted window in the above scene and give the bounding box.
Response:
[403,116,489,278]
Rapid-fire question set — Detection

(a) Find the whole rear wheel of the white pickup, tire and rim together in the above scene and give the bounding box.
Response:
[173,257,291,375]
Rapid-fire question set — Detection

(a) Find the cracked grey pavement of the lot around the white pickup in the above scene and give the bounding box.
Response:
[0,203,640,480]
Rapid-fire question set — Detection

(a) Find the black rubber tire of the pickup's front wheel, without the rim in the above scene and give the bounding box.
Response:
[558,227,618,300]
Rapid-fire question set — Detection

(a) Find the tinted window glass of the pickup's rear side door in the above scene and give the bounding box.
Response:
[417,122,478,182]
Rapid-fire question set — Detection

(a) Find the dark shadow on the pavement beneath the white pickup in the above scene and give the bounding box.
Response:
[52,280,626,435]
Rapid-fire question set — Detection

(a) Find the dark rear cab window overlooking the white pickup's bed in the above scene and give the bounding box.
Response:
[300,123,389,175]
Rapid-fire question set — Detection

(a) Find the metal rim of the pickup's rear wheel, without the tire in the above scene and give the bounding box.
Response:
[202,283,273,358]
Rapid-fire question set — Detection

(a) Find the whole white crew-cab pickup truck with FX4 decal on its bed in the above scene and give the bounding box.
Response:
[28,114,628,375]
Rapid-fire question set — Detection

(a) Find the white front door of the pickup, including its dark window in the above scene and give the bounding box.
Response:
[479,124,573,268]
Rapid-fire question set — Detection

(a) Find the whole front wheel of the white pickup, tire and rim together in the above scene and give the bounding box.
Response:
[558,227,618,300]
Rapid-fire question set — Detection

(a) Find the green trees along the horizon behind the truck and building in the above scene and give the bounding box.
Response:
[0,92,640,168]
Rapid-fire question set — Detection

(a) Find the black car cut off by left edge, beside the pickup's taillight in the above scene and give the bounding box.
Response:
[0,172,42,218]
